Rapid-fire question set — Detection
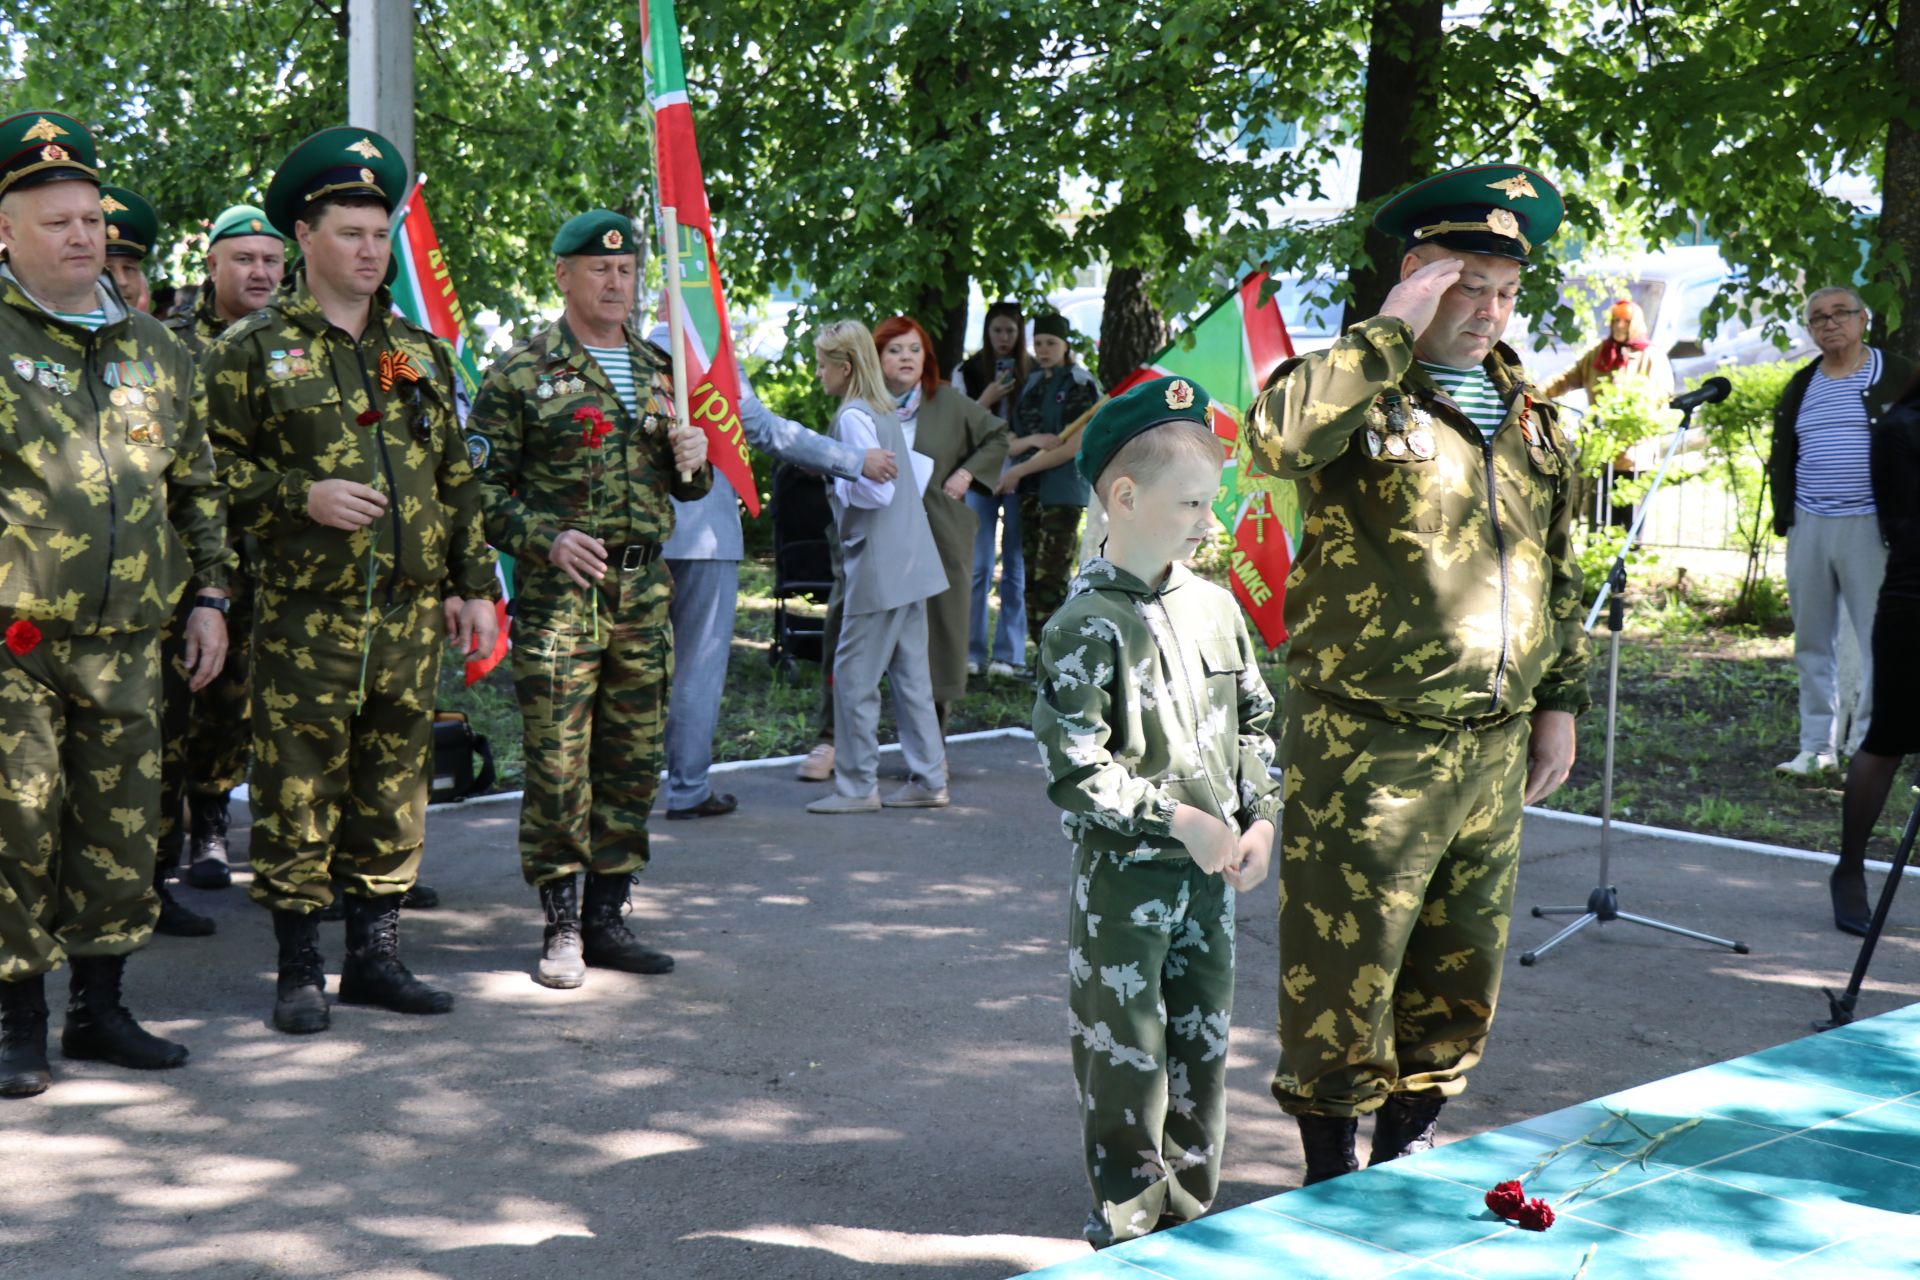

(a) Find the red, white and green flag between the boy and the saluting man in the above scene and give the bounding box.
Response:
[1112,271,1300,649]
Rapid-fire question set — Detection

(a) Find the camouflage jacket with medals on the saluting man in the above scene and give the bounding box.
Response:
[1248,317,1588,729]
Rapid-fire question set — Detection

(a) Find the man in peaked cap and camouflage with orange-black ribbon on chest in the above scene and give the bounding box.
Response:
[202,127,499,1032]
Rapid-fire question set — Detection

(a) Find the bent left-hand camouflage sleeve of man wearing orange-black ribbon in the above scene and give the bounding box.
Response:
[196,336,313,537]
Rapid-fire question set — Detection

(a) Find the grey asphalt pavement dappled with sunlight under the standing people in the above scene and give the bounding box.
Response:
[0,739,1920,1280]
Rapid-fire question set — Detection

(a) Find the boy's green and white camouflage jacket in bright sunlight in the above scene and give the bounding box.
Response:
[1033,558,1281,858]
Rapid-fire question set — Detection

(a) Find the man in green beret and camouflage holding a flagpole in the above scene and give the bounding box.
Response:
[467,209,712,988]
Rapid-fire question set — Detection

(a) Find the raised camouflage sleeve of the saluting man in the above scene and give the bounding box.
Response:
[1246,315,1413,480]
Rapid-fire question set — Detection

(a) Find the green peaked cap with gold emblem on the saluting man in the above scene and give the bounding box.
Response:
[1373,165,1567,263]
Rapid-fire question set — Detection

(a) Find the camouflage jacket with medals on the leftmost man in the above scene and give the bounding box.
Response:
[0,267,230,637]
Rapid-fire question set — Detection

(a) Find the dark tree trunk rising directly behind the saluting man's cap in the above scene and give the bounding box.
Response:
[1344,0,1446,324]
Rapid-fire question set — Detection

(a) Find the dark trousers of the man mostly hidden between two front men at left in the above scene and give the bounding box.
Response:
[159,574,253,862]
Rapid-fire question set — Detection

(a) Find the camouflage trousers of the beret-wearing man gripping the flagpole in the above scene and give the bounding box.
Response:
[513,560,674,885]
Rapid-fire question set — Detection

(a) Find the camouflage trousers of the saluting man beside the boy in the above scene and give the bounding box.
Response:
[1273,681,1530,1115]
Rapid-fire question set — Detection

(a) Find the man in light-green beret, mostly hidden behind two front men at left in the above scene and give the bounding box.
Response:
[151,205,286,921]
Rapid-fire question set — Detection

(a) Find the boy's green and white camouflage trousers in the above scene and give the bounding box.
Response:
[1068,848,1235,1247]
